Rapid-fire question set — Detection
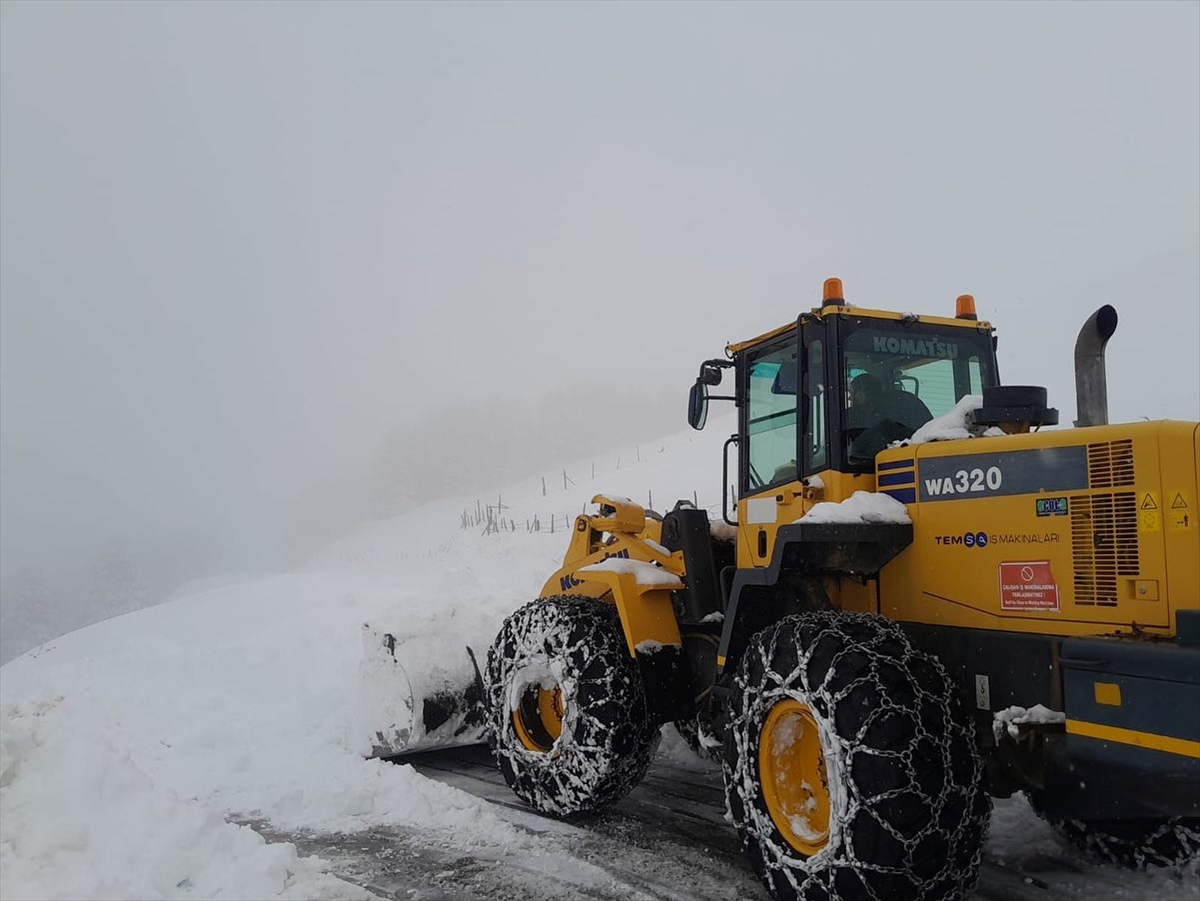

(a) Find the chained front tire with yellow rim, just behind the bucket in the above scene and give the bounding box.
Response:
[485,596,659,816]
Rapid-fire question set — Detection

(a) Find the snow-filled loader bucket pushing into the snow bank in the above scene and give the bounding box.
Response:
[354,625,485,757]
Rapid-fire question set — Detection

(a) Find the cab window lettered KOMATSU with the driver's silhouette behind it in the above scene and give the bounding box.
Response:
[841,319,996,468]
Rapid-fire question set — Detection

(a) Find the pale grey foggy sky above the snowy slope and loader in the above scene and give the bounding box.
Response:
[0,0,1200,662]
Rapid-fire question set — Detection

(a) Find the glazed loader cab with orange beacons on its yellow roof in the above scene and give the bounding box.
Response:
[689,280,998,521]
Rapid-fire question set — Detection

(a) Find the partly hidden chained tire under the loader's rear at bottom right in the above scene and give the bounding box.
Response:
[1026,792,1200,870]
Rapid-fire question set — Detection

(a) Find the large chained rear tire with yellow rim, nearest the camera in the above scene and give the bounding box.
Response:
[725,611,991,901]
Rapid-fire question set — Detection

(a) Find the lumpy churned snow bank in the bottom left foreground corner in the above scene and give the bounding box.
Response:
[0,693,371,899]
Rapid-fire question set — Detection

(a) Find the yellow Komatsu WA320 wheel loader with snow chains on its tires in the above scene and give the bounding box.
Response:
[367,278,1200,901]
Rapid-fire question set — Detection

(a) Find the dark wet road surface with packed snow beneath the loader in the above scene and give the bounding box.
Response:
[254,739,1198,901]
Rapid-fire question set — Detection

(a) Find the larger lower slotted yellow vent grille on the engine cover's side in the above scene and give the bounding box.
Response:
[1070,494,1139,607]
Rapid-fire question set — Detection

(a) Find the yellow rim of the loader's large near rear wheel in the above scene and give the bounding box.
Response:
[758,698,829,857]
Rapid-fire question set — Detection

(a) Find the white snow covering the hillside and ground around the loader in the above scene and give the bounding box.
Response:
[0,420,1200,899]
